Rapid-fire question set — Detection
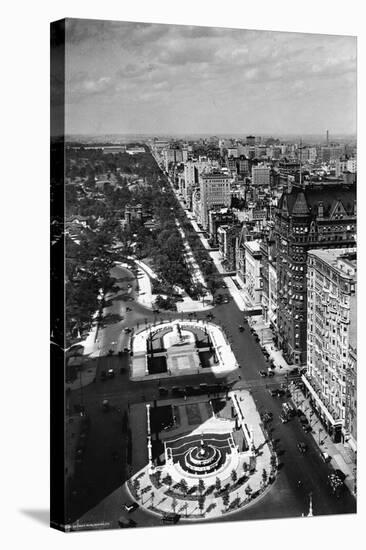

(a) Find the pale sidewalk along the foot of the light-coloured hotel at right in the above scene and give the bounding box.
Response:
[289,384,356,494]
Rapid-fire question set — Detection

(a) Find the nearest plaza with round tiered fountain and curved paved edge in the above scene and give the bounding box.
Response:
[126,390,277,520]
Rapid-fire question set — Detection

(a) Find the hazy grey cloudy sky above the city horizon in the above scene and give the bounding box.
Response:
[65,19,357,135]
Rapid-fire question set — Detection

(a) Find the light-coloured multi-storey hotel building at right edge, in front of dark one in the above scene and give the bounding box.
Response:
[303,248,357,448]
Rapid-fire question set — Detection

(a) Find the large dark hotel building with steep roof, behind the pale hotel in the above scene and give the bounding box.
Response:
[275,182,356,365]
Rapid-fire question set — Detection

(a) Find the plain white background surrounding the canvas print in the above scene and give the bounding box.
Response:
[0,0,366,549]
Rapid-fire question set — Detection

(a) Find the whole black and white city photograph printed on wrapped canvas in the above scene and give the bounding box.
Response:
[51,18,357,531]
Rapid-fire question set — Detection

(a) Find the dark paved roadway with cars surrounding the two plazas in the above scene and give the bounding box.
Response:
[67,157,356,526]
